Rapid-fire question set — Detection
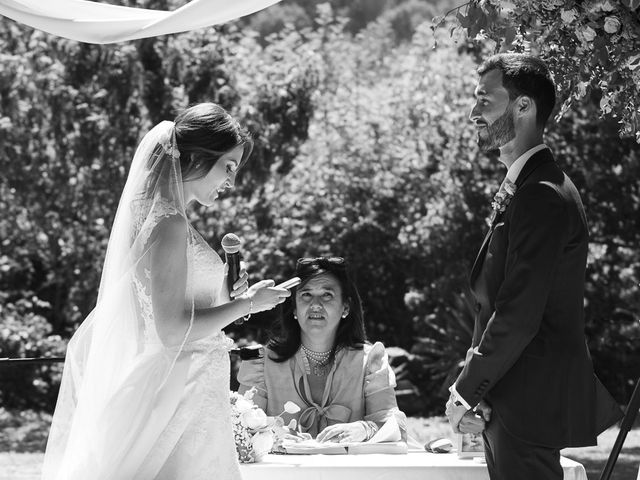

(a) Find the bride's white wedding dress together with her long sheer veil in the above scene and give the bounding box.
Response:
[42,122,241,480]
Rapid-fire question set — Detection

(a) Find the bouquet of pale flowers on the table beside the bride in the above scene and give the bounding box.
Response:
[230,388,300,463]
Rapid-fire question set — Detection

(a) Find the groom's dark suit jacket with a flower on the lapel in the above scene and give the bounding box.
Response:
[456,149,621,448]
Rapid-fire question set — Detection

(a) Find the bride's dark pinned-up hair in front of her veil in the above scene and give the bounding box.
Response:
[174,103,253,180]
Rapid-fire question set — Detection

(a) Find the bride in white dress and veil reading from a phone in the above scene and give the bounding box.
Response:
[42,103,289,480]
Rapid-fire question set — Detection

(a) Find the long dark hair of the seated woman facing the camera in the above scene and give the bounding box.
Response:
[267,257,366,362]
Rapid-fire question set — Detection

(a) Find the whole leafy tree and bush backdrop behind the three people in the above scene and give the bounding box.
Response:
[0,0,640,436]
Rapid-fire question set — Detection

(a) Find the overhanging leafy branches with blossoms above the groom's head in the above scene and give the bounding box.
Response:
[434,0,640,143]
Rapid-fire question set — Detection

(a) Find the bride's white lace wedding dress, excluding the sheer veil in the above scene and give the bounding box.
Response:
[126,200,240,480]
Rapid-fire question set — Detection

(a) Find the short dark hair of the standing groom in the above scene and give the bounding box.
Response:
[478,53,556,127]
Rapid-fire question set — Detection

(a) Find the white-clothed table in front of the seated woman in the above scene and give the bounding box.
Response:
[240,452,587,480]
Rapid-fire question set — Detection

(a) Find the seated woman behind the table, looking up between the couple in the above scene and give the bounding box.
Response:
[238,257,406,442]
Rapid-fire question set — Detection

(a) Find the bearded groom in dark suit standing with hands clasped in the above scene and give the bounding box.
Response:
[447,54,621,480]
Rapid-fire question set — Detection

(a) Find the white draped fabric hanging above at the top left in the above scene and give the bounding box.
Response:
[0,0,280,43]
